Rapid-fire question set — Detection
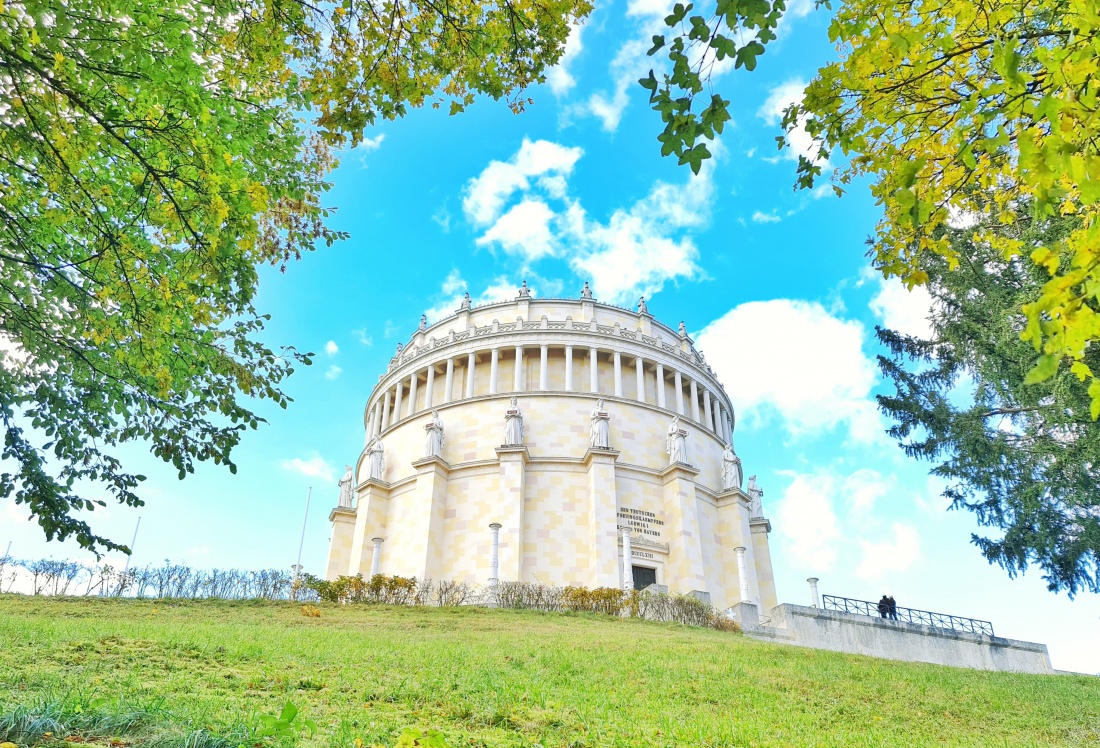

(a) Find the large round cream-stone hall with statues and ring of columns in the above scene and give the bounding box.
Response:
[327,284,777,611]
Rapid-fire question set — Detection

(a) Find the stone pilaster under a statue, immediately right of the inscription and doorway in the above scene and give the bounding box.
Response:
[660,462,710,592]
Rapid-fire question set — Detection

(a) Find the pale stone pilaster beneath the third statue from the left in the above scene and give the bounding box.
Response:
[404,458,451,579]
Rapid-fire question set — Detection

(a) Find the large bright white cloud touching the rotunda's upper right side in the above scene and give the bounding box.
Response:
[697,299,882,442]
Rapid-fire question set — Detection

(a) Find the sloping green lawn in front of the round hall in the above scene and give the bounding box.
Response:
[0,595,1100,748]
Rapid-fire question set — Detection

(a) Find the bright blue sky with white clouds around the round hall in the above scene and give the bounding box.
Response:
[0,0,1100,672]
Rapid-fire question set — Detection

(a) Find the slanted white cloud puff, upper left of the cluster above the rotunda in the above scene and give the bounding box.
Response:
[462,138,584,226]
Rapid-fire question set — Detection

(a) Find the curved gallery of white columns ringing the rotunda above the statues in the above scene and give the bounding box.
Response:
[367,345,733,441]
